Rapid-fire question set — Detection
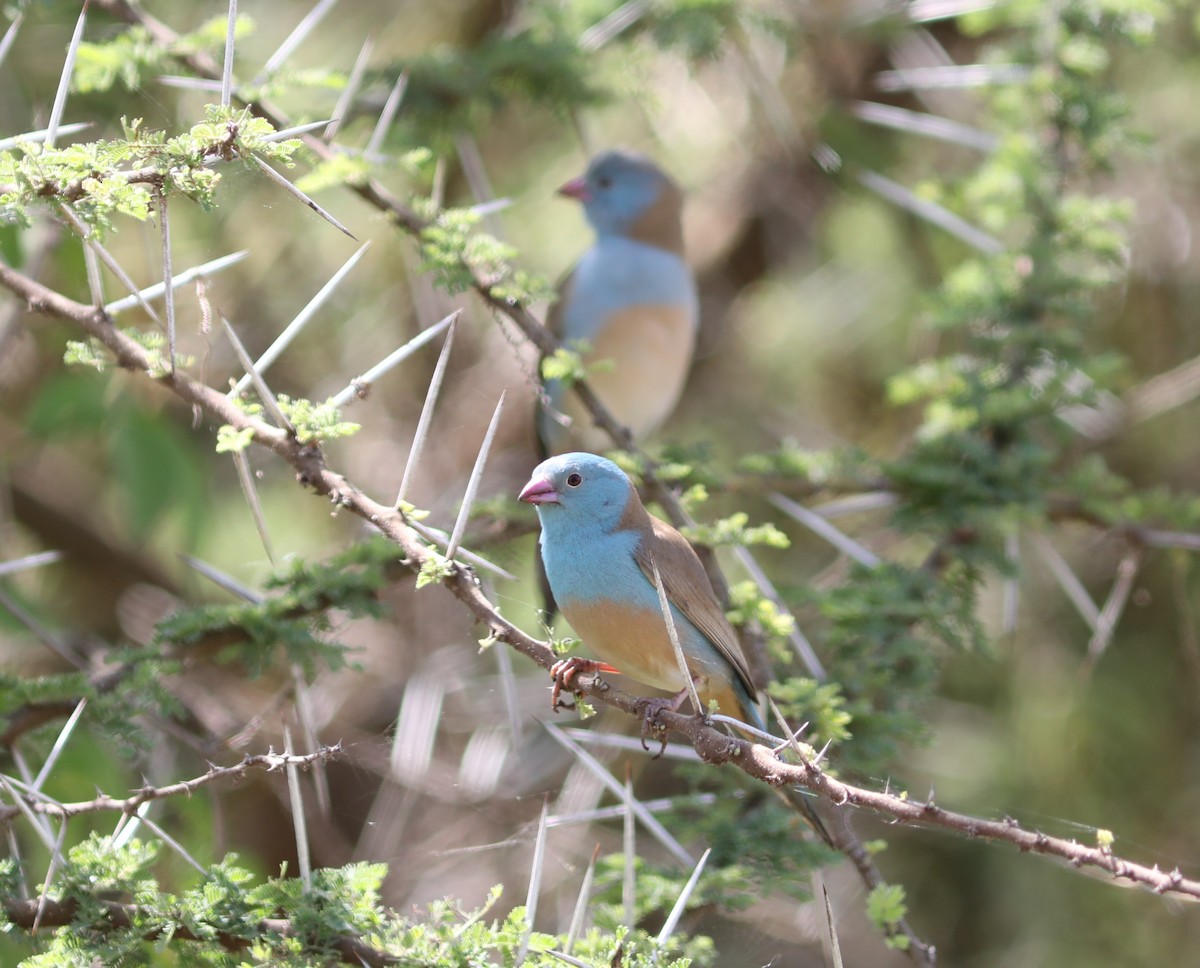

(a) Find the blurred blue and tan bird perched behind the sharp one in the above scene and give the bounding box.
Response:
[538,150,700,456]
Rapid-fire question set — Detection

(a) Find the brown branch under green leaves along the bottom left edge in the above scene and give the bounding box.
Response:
[2,897,400,968]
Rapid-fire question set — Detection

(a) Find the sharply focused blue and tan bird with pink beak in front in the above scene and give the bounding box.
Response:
[520,453,763,734]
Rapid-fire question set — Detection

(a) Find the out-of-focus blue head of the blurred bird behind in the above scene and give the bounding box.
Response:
[558,150,683,244]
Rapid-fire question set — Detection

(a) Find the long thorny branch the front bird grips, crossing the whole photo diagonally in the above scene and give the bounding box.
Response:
[0,257,1200,916]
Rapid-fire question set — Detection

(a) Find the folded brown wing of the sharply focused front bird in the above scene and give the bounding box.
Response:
[634,515,758,696]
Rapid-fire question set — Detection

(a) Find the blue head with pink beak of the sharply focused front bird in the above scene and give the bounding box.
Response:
[520,453,635,531]
